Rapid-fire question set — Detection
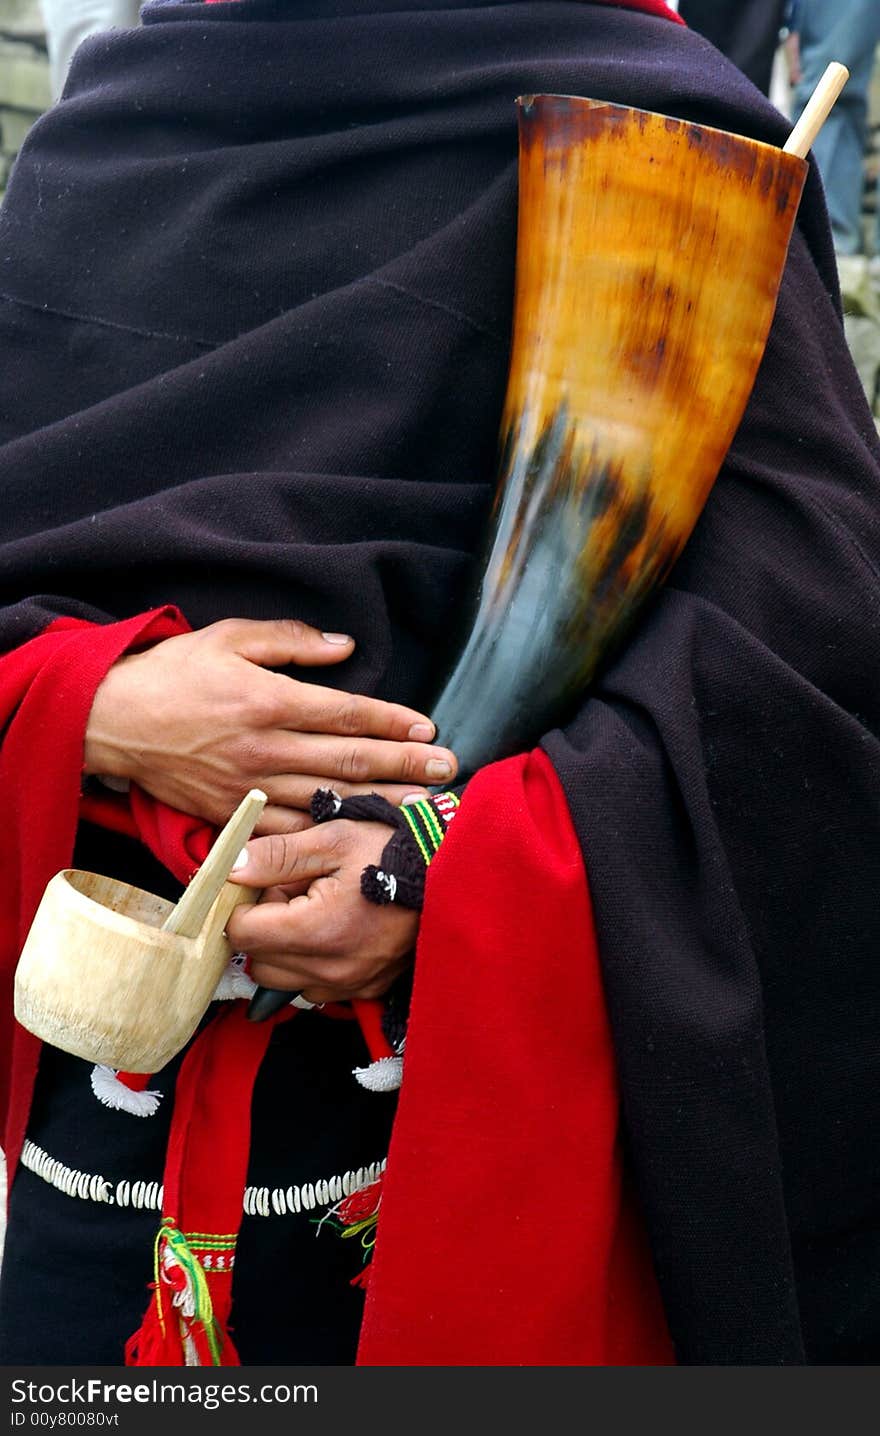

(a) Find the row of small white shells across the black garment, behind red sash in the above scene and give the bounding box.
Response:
[22,1140,385,1216]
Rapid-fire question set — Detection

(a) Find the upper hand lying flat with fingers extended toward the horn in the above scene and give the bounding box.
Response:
[85,619,455,833]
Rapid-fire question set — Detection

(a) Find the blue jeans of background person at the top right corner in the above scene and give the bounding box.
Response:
[792,0,880,254]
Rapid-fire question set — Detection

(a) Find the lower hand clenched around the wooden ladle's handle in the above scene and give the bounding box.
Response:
[227,819,419,1002]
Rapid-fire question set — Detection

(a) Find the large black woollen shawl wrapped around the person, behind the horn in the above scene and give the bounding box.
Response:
[0,0,880,1364]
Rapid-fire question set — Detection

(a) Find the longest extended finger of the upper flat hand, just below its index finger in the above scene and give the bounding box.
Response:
[271,732,458,801]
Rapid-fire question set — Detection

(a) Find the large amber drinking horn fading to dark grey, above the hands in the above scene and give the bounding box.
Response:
[432,95,807,775]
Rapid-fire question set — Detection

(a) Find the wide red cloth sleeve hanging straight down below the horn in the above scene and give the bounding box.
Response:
[357,752,672,1366]
